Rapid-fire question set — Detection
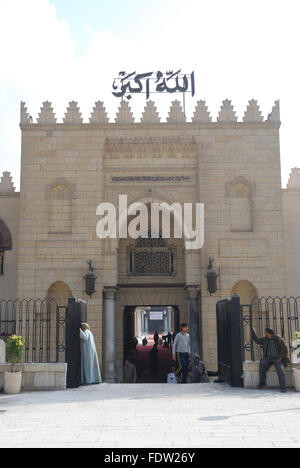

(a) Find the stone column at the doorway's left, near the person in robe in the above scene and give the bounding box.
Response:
[103,287,117,383]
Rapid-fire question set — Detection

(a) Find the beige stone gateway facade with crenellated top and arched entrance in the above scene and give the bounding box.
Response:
[0,100,300,382]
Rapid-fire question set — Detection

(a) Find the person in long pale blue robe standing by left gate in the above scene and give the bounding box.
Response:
[80,323,102,385]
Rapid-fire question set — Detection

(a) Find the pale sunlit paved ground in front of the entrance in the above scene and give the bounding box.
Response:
[0,384,300,448]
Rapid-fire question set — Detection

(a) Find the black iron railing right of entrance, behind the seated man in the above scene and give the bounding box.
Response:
[241,297,300,361]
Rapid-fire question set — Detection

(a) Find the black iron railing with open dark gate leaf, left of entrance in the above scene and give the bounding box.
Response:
[0,296,87,388]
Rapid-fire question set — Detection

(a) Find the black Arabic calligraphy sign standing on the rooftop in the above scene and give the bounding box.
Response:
[112,70,195,100]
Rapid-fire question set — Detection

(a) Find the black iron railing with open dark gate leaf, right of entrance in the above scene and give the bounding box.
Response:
[217,295,300,387]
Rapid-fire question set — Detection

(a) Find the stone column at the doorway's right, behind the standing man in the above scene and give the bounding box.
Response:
[186,286,202,356]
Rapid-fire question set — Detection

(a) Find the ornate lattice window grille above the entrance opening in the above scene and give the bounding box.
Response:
[129,232,176,276]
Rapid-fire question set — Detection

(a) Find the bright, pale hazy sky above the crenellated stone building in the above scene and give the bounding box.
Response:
[0,0,300,187]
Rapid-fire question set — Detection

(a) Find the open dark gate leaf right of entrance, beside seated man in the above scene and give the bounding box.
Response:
[217,295,243,387]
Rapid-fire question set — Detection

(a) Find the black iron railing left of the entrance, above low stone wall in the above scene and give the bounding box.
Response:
[0,299,66,363]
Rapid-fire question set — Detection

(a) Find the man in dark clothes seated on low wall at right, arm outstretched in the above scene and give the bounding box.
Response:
[252,328,289,393]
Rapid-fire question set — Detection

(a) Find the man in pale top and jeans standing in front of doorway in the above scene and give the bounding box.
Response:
[173,322,191,384]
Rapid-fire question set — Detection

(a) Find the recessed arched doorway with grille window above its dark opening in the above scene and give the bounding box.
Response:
[116,199,189,383]
